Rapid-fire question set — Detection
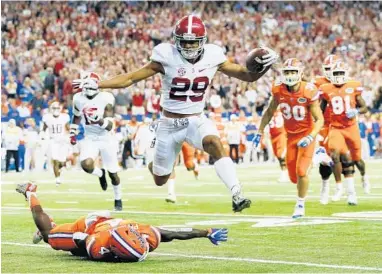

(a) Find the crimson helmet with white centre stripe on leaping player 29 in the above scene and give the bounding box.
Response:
[173,15,207,60]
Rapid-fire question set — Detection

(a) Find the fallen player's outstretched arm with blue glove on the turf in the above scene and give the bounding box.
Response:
[158,228,228,245]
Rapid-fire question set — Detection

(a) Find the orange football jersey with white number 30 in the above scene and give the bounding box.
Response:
[272,81,320,134]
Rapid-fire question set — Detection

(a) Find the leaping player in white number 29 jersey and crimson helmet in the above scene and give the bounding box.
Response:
[73,15,278,212]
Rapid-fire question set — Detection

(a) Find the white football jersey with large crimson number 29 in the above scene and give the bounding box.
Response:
[151,43,227,114]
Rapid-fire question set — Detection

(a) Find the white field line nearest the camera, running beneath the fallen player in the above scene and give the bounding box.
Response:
[2,242,382,271]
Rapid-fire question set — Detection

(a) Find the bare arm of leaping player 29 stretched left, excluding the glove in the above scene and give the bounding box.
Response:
[98,61,164,88]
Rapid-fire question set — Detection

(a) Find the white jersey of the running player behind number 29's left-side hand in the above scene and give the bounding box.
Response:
[73,92,114,137]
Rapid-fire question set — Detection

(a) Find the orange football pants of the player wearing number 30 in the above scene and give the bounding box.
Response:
[286,131,315,184]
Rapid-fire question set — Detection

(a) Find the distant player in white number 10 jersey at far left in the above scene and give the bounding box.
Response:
[41,102,70,186]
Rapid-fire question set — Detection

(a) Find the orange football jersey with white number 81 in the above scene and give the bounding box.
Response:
[320,81,363,128]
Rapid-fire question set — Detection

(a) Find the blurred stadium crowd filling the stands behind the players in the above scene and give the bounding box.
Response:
[1,1,382,170]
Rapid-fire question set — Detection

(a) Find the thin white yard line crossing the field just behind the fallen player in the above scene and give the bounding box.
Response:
[1,206,382,221]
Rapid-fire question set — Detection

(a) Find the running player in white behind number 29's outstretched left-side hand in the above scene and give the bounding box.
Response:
[70,73,122,211]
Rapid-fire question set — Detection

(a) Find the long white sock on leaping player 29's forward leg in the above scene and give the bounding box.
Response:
[215,157,241,196]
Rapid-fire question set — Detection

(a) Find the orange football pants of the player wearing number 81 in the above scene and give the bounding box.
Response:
[328,123,361,161]
